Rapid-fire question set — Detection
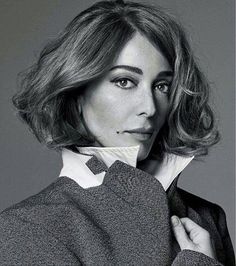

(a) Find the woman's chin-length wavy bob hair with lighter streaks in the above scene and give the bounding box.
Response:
[13,1,219,156]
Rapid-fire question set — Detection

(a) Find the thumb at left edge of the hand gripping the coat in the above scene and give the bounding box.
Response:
[171,215,191,250]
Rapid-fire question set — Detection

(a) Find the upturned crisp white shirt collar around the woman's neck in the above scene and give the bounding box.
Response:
[60,146,194,190]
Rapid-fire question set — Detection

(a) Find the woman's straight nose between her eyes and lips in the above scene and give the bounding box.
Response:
[137,86,156,117]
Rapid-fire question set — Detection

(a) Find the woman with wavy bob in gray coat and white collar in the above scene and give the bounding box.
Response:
[0,1,234,265]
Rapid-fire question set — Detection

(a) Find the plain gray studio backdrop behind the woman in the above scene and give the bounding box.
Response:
[0,0,235,248]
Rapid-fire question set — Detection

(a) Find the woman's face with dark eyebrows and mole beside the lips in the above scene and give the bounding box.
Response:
[79,33,172,161]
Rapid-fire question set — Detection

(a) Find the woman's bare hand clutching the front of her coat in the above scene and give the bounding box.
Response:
[171,215,216,259]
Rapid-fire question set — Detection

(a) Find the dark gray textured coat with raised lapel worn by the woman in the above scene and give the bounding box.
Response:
[0,157,235,266]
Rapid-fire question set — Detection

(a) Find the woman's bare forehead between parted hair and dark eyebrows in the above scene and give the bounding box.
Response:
[114,32,171,74]
